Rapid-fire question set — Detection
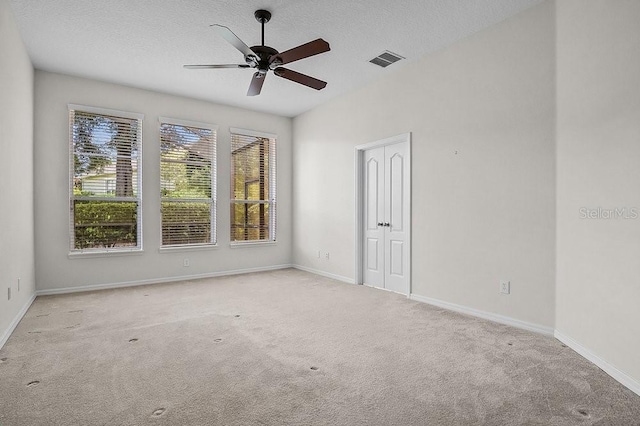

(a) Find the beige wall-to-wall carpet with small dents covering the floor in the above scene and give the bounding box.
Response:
[0,270,640,426]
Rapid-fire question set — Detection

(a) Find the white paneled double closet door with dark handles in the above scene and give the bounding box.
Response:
[362,142,411,295]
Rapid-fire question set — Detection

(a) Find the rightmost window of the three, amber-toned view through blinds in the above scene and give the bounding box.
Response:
[231,129,276,242]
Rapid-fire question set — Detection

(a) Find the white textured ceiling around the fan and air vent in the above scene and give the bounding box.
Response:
[11,0,540,117]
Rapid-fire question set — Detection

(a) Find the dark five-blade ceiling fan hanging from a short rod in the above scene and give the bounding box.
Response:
[184,9,331,96]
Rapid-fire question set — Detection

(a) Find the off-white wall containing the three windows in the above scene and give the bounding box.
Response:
[35,71,292,291]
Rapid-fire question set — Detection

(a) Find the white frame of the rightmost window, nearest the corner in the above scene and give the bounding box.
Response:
[229,127,278,247]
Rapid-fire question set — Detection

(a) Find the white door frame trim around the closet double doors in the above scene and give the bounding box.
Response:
[354,132,412,297]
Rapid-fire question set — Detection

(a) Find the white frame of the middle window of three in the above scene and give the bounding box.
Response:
[158,117,219,251]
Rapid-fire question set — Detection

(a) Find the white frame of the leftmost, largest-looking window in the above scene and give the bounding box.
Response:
[67,104,144,258]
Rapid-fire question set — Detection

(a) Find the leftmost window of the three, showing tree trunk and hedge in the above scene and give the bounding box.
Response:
[69,105,143,253]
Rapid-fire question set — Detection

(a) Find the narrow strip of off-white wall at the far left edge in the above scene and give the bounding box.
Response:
[0,0,35,347]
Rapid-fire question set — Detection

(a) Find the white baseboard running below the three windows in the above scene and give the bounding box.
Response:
[36,265,292,296]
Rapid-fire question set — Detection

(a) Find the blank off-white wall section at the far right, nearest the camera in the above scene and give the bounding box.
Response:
[556,0,640,392]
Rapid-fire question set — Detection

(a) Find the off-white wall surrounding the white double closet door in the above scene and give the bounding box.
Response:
[293,2,555,329]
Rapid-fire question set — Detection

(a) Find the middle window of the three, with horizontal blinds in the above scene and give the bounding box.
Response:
[160,118,217,246]
